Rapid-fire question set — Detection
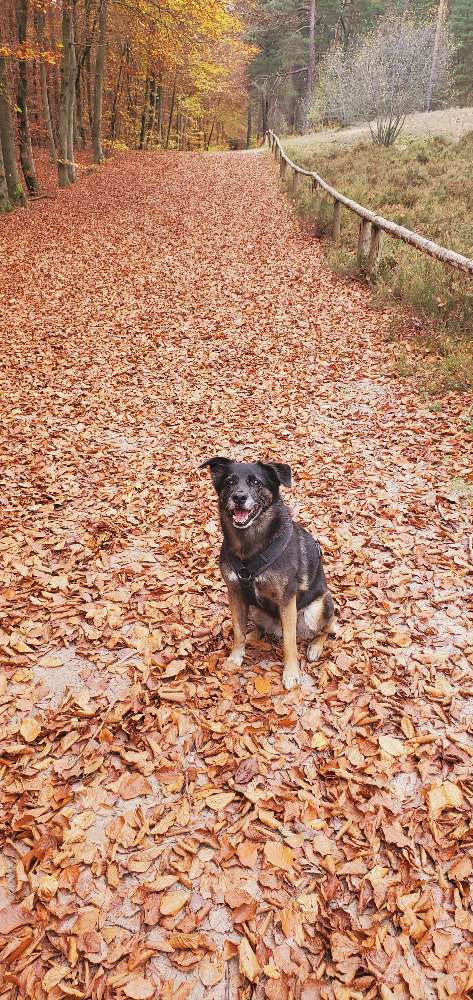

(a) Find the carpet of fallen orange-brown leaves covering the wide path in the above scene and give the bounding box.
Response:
[0,153,473,1000]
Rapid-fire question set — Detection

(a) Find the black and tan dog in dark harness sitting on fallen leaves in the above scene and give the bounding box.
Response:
[201,457,335,688]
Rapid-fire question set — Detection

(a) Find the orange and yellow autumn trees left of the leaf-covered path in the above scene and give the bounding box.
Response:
[0,0,253,209]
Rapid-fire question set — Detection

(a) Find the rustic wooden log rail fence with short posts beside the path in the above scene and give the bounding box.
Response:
[266,131,473,275]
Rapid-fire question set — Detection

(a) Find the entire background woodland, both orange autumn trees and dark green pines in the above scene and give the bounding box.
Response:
[0,0,473,211]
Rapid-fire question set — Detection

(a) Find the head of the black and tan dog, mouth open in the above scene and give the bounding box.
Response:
[200,457,291,530]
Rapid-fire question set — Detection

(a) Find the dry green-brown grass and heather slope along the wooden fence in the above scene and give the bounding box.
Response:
[284,109,473,392]
